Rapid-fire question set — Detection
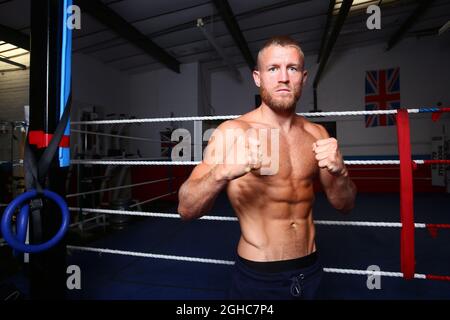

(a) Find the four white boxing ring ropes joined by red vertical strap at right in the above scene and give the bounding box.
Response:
[68,108,450,298]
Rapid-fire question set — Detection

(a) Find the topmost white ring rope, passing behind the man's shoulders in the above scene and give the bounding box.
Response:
[72,109,426,125]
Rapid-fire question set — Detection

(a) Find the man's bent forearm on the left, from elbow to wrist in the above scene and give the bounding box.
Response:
[178,166,228,220]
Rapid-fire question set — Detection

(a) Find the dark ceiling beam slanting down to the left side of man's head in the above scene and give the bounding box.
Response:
[214,0,256,71]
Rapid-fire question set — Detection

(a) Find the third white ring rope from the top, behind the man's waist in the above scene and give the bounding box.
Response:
[69,207,426,229]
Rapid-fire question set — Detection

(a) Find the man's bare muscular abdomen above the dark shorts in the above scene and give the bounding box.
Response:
[228,181,316,261]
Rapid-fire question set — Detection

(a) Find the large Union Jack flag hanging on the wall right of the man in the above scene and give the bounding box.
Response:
[365,68,400,128]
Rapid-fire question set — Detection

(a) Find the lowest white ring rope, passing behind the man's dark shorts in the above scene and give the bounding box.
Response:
[67,245,426,279]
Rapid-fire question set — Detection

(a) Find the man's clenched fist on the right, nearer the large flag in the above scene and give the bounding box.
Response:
[313,138,347,176]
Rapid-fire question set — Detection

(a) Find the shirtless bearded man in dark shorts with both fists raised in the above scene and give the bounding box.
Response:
[178,36,356,299]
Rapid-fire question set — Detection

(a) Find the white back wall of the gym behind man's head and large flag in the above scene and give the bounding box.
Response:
[0,37,450,162]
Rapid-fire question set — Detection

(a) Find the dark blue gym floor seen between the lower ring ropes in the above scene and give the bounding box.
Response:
[44,193,450,300]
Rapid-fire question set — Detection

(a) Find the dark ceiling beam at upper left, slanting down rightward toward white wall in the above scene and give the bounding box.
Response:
[76,0,180,73]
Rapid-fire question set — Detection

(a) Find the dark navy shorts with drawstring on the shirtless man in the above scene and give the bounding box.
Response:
[229,252,323,300]
